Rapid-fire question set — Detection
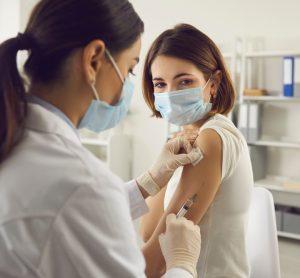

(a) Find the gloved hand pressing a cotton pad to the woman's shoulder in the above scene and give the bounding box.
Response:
[136,136,203,196]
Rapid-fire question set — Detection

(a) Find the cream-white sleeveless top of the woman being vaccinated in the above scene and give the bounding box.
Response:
[164,114,253,278]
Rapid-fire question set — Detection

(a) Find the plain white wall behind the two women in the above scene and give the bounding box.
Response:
[4,0,300,176]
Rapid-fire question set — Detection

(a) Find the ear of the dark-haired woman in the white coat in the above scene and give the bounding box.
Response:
[82,40,105,84]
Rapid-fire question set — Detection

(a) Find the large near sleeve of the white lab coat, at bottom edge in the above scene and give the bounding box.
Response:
[41,181,145,278]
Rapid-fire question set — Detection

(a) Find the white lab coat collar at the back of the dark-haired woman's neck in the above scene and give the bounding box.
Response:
[25,103,81,145]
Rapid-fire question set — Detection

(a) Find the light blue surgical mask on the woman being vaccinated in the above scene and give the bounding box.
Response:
[154,80,212,126]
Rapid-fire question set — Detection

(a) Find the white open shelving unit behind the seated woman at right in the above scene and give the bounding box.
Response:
[238,44,300,239]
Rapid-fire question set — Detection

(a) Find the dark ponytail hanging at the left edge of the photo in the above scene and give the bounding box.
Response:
[0,36,26,163]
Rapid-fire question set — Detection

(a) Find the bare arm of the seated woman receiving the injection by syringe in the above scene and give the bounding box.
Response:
[143,129,222,272]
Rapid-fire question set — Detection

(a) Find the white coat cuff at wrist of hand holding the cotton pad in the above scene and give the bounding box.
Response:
[125,180,149,219]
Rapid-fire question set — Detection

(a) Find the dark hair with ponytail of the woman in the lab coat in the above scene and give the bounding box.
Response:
[0,0,144,163]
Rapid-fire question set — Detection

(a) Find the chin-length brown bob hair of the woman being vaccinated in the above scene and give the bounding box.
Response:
[143,24,235,118]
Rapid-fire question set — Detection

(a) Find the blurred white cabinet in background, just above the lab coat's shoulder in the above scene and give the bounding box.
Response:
[80,130,132,181]
